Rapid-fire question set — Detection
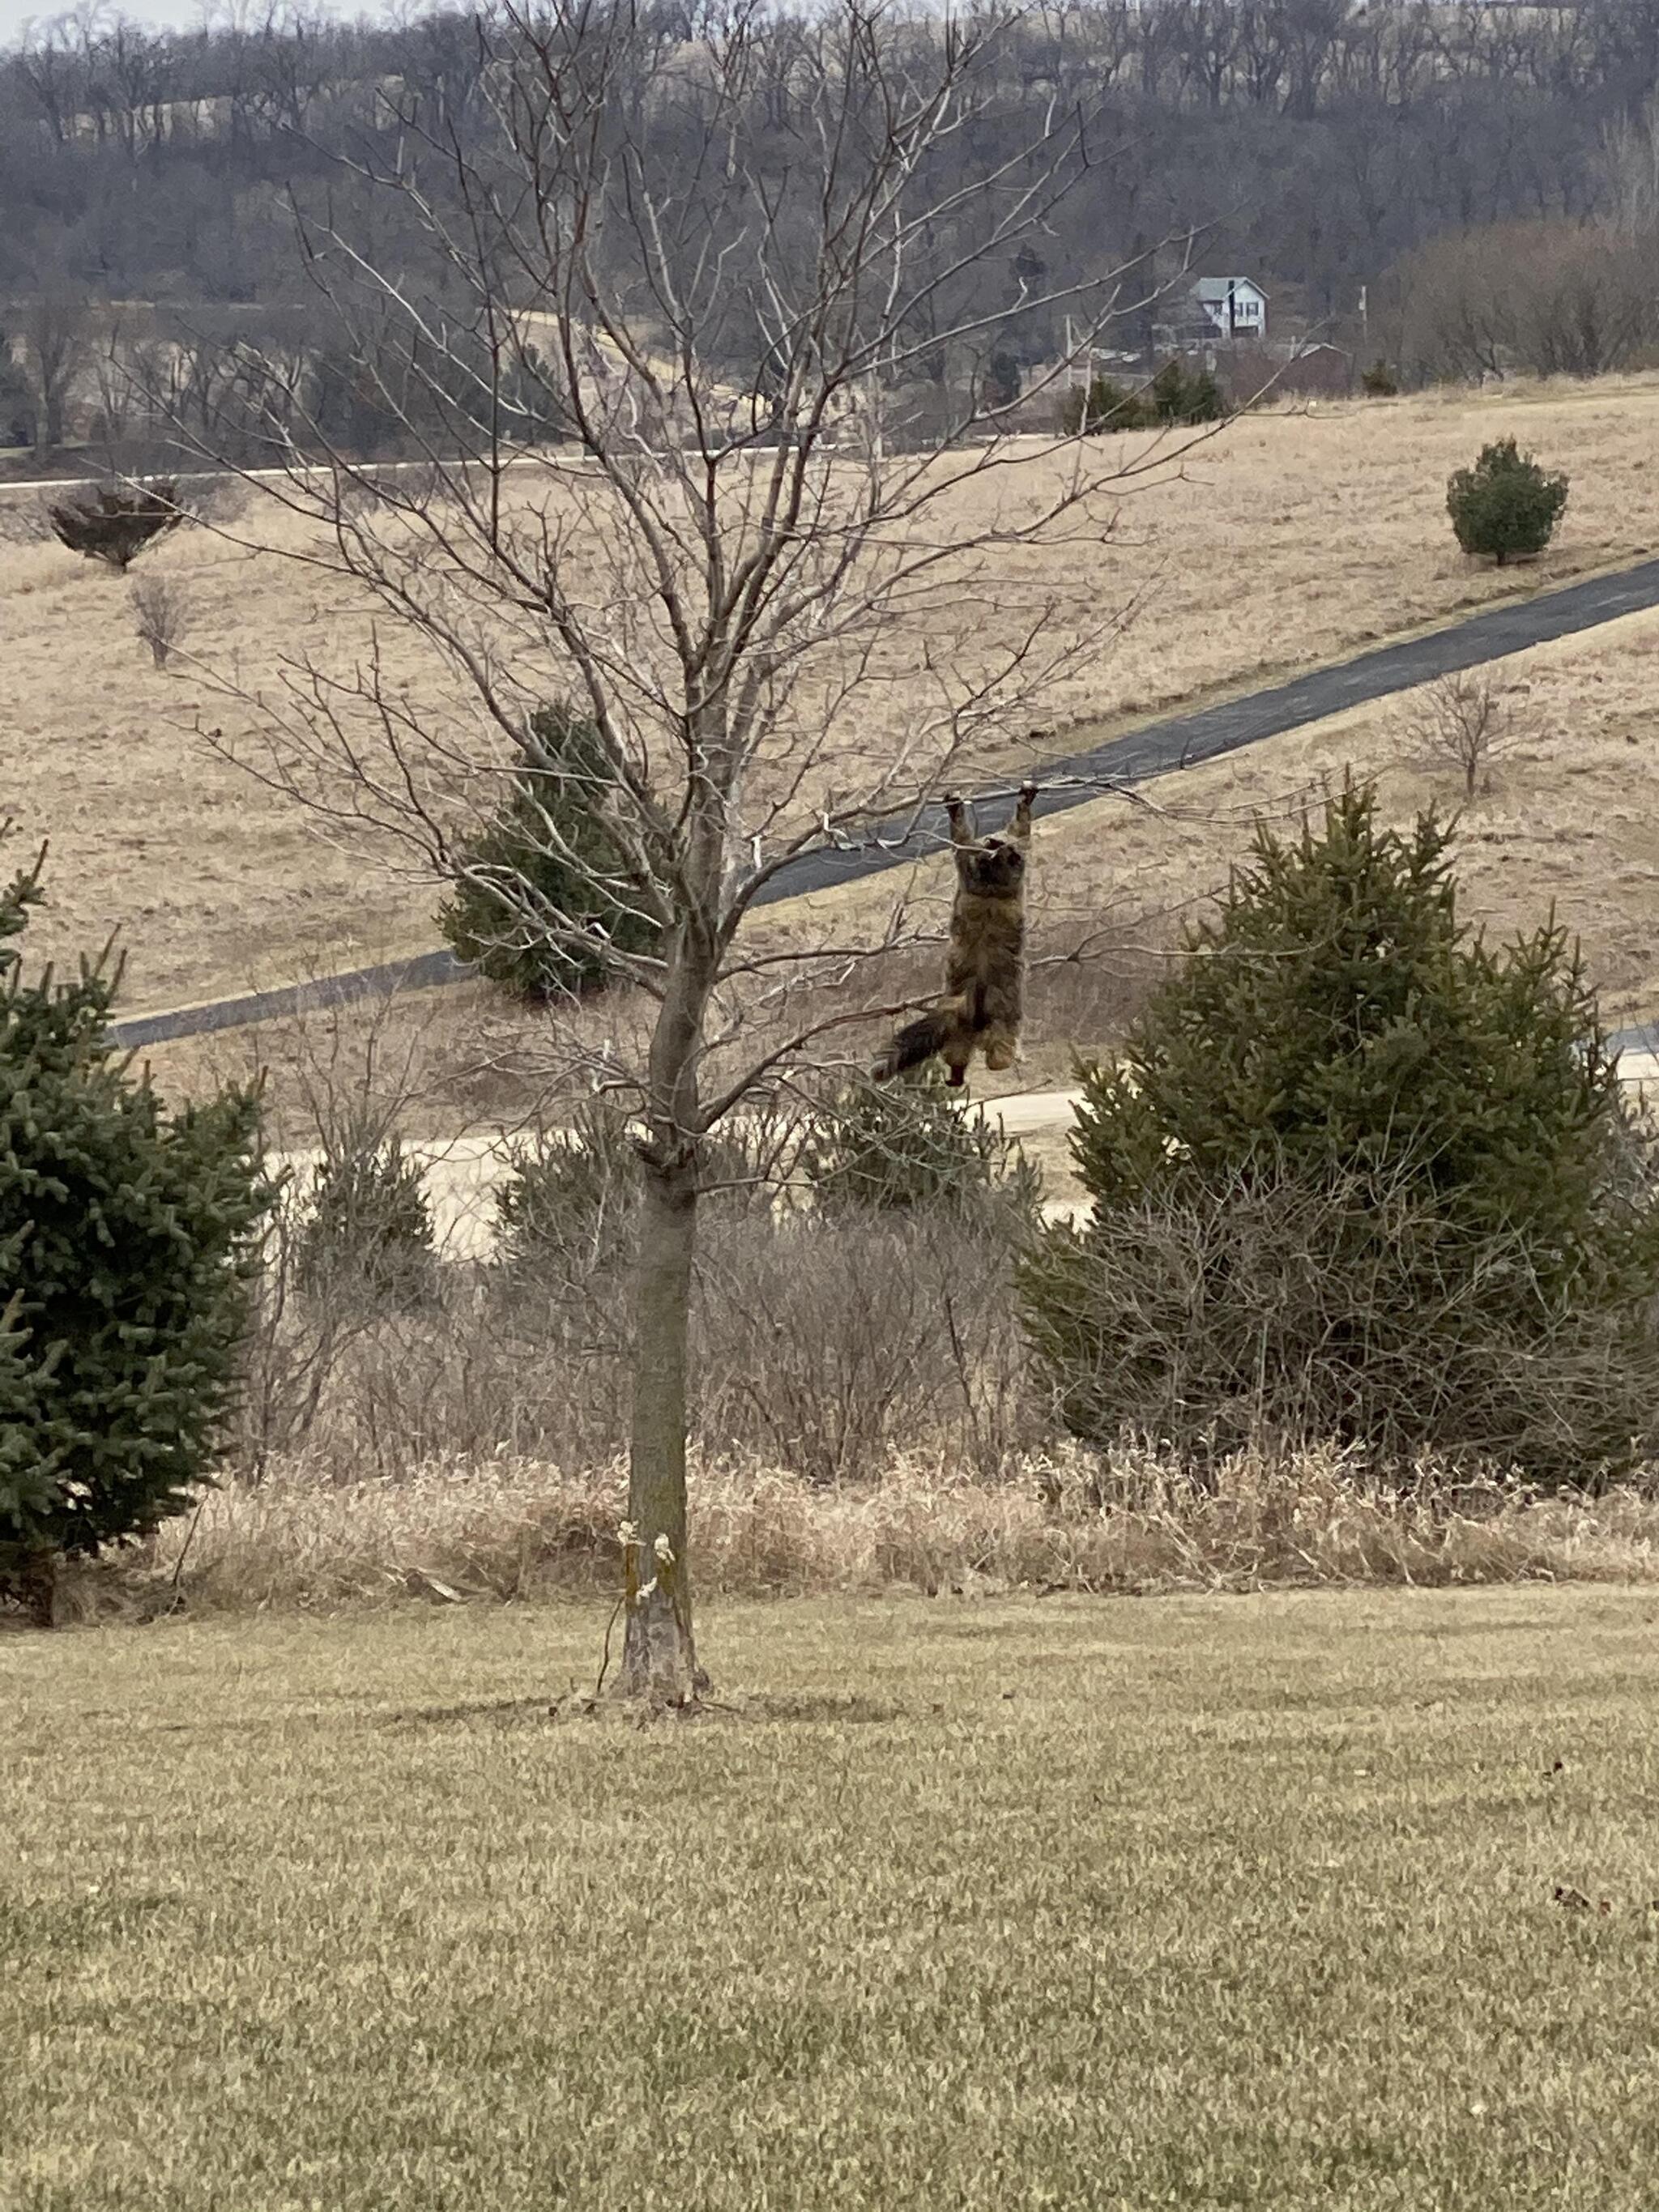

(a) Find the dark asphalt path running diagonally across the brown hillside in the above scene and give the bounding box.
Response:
[113,560,1659,1046]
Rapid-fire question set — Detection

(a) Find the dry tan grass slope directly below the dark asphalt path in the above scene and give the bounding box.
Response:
[133,611,1659,1159]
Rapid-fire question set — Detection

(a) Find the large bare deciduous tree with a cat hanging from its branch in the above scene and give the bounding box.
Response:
[185,0,1203,1703]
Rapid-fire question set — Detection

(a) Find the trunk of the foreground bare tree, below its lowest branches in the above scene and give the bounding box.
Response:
[620,1146,703,1706]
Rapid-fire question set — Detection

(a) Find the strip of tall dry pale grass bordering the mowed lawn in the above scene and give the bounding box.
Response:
[64,1447,1659,1619]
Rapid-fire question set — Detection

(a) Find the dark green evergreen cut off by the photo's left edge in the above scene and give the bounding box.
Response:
[0,836,270,1619]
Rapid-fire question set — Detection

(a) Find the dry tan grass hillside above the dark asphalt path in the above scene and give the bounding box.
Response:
[0,367,1659,1011]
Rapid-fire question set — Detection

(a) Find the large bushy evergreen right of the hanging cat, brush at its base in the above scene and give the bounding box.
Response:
[1022,787,1659,1480]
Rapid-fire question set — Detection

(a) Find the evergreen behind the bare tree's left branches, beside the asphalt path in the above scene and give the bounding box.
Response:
[438,705,659,998]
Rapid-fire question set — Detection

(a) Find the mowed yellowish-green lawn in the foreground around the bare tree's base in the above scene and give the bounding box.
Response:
[0,1586,1659,2212]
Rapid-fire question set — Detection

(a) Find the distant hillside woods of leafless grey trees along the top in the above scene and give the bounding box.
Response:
[0,0,1659,451]
